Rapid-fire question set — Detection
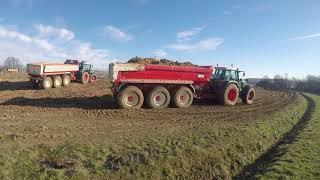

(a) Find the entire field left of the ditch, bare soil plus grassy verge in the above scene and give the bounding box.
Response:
[0,72,306,179]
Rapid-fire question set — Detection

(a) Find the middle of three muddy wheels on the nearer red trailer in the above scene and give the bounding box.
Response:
[146,86,170,108]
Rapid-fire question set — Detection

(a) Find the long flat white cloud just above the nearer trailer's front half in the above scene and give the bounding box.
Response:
[167,38,224,52]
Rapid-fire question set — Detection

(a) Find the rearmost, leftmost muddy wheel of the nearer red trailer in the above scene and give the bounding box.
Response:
[117,86,144,109]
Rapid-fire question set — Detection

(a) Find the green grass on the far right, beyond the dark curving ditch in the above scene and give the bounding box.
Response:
[255,94,320,179]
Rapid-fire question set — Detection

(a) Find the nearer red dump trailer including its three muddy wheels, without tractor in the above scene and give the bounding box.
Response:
[109,63,214,108]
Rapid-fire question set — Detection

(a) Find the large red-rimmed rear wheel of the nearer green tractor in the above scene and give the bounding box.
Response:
[217,84,239,106]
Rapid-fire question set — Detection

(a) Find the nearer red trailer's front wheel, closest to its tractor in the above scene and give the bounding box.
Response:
[171,86,193,108]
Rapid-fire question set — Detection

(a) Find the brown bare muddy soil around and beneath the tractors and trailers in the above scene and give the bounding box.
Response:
[0,72,297,146]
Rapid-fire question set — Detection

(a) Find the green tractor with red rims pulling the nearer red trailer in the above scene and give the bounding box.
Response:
[209,67,256,106]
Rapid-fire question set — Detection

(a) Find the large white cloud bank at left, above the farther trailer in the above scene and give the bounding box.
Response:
[0,25,110,68]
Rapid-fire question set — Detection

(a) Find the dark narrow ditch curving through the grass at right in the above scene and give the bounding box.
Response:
[233,94,315,179]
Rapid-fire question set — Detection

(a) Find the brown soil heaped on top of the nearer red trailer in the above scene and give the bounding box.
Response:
[128,57,198,66]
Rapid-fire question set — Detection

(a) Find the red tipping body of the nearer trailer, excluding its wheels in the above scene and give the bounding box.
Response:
[109,63,214,98]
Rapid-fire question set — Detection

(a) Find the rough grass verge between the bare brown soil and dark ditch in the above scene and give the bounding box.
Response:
[0,94,307,179]
